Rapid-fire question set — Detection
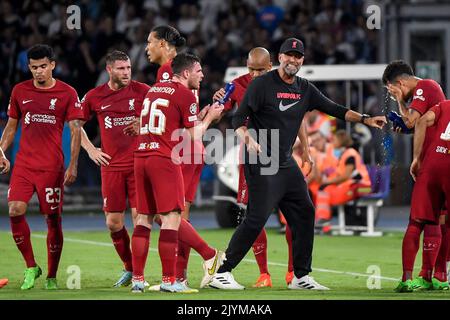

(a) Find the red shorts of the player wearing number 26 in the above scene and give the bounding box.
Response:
[134,156,184,214]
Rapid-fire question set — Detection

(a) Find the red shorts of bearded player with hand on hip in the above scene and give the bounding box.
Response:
[102,168,136,212]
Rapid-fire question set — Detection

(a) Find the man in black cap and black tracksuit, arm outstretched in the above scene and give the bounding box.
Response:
[209,38,386,290]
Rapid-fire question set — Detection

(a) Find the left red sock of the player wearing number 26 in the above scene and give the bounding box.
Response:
[131,225,151,281]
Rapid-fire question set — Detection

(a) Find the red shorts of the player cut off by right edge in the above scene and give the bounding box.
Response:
[411,168,450,223]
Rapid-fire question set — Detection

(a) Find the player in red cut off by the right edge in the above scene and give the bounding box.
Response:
[410,100,450,290]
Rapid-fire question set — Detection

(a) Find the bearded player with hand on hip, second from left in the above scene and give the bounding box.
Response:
[81,50,150,287]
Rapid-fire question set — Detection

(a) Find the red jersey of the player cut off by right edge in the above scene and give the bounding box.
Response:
[423,100,450,168]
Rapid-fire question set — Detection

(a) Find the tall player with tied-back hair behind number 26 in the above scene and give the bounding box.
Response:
[142,25,223,290]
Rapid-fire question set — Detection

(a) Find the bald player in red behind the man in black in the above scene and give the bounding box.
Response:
[213,47,298,288]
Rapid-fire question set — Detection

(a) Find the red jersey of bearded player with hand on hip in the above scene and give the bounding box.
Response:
[81,80,150,171]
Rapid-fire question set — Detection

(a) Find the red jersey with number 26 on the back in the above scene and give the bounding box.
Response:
[135,81,199,163]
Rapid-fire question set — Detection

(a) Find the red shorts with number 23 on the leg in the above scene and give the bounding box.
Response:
[8,167,64,214]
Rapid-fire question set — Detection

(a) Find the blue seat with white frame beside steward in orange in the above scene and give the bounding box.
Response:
[333,166,391,237]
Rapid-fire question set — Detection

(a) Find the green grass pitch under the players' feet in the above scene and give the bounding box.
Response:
[0,230,450,300]
